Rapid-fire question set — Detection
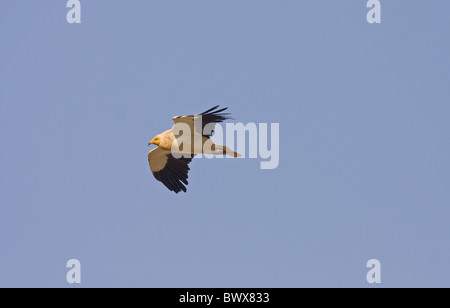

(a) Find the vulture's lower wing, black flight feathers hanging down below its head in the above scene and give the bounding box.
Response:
[148,147,193,193]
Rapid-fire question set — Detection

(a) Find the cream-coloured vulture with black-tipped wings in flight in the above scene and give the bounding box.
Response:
[148,105,241,194]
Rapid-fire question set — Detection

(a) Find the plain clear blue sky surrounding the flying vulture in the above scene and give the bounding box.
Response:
[0,0,450,287]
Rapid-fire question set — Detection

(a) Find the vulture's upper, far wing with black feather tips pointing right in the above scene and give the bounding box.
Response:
[172,106,231,137]
